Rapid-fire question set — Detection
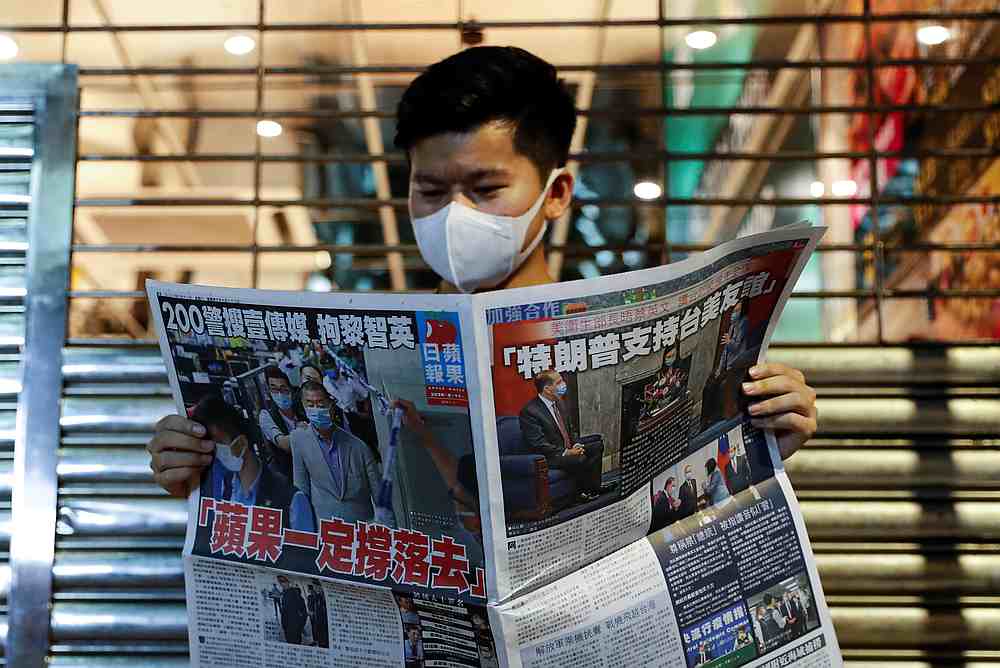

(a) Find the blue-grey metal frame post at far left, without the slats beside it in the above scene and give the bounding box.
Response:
[0,65,78,668]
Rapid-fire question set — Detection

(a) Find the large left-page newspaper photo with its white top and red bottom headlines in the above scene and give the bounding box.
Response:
[150,283,494,600]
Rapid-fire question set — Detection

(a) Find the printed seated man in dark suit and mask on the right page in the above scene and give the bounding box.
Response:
[518,371,604,502]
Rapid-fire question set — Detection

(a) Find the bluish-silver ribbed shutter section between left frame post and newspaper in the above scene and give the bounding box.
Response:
[51,341,187,667]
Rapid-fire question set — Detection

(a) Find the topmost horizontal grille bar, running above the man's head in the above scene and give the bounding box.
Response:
[0,12,997,33]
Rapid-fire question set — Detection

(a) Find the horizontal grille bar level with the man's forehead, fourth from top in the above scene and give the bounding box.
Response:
[78,148,1000,164]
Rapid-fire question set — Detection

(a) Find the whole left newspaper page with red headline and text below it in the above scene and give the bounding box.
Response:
[148,282,498,668]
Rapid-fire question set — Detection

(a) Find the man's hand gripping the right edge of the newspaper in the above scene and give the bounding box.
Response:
[743,362,816,459]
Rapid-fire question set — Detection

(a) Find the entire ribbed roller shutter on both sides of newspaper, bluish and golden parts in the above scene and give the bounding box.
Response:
[45,345,1000,668]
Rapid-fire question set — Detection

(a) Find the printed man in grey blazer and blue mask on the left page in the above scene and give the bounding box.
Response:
[291,381,382,524]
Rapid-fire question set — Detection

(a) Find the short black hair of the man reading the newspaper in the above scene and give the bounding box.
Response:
[395,46,576,180]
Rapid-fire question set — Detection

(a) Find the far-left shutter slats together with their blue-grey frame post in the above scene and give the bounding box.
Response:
[0,65,77,666]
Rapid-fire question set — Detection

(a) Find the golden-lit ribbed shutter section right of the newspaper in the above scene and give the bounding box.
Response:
[772,346,1000,667]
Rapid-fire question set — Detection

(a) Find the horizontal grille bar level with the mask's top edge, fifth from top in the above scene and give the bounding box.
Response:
[76,195,1000,209]
